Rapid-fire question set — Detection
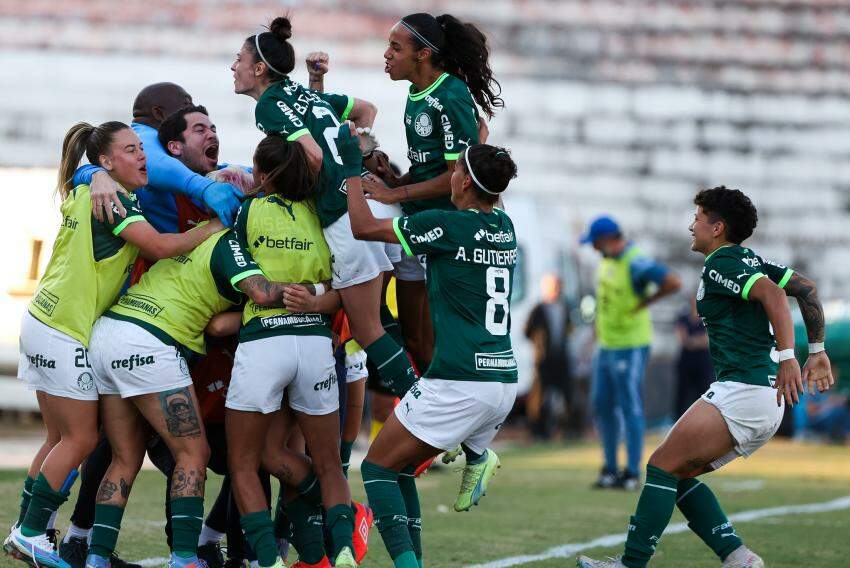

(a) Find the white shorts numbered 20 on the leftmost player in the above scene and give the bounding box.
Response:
[18,312,97,400]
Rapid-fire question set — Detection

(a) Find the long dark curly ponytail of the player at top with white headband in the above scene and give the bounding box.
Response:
[401,13,505,118]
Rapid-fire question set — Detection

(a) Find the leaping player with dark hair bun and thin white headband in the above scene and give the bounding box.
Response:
[231,18,416,406]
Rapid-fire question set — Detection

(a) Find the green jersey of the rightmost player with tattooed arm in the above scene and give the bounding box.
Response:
[697,245,794,386]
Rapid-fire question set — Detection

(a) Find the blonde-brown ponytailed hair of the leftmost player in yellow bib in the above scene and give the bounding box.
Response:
[56,120,130,201]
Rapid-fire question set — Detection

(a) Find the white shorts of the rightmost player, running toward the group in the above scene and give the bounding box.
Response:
[702,381,784,469]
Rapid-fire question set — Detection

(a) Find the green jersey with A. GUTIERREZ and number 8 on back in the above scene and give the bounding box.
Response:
[393,208,517,383]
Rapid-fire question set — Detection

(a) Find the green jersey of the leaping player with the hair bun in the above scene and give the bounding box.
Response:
[254,77,354,227]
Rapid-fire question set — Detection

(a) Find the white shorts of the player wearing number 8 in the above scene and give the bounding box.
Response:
[395,378,517,453]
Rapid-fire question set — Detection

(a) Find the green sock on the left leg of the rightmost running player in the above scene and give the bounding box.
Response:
[621,465,679,568]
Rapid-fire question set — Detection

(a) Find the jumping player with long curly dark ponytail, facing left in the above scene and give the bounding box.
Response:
[363,13,504,369]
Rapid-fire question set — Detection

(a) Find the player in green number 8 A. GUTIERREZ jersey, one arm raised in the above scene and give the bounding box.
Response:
[339,128,517,568]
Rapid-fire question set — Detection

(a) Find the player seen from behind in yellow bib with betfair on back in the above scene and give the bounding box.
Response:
[226,135,356,567]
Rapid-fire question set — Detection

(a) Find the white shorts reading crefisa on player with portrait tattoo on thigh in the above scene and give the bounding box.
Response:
[89,317,192,398]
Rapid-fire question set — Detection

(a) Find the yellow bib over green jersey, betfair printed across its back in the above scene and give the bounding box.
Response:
[234,195,332,341]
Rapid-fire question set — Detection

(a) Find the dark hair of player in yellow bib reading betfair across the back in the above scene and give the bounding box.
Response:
[254,134,316,201]
